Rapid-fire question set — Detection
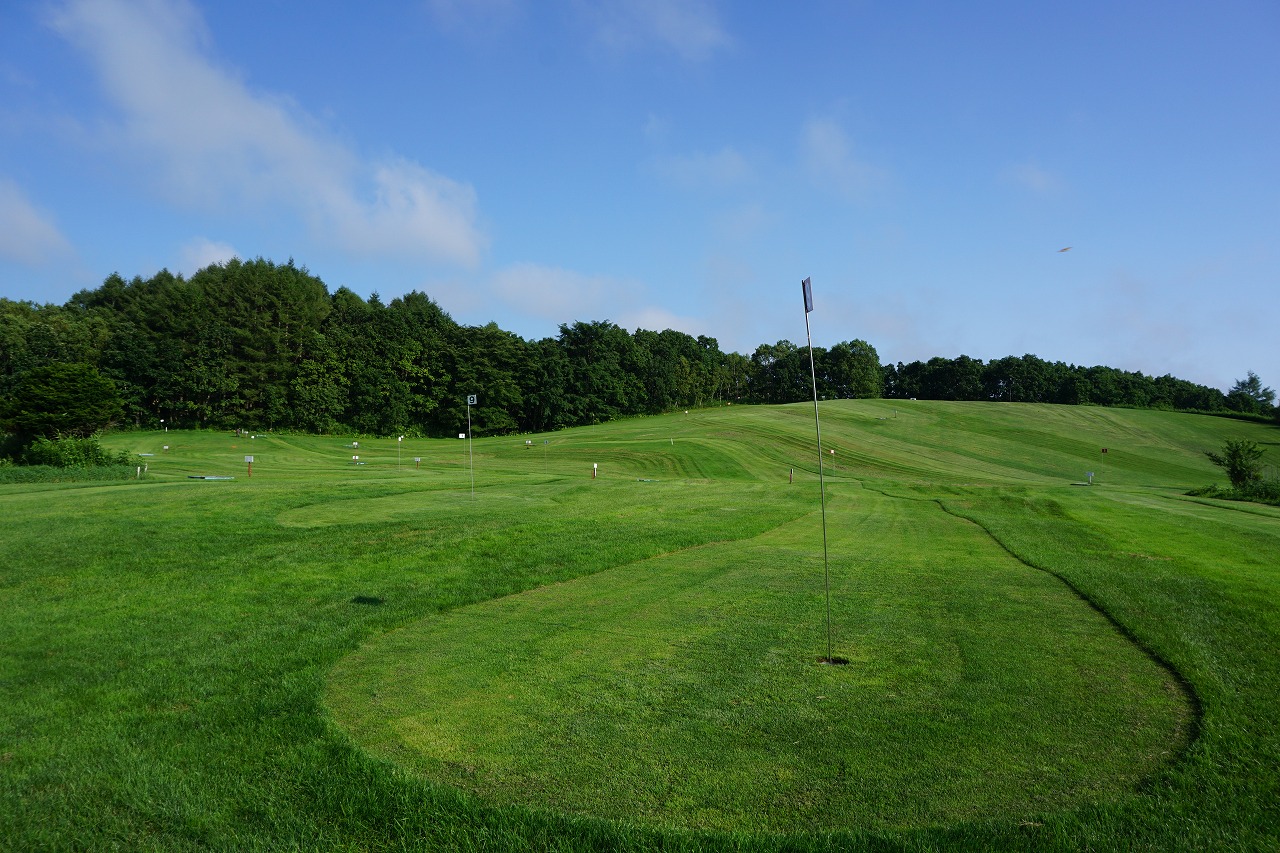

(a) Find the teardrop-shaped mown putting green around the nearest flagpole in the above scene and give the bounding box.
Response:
[328,485,1190,833]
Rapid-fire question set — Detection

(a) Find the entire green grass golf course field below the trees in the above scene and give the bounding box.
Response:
[0,401,1280,850]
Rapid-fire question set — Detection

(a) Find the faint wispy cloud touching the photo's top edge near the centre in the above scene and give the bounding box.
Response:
[585,0,732,61]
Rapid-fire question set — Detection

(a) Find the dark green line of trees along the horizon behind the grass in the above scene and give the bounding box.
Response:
[0,259,1274,439]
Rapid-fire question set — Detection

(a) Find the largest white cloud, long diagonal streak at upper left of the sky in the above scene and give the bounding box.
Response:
[52,0,486,266]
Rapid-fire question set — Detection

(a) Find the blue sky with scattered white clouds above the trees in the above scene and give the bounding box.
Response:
[0,0,1280,388]
